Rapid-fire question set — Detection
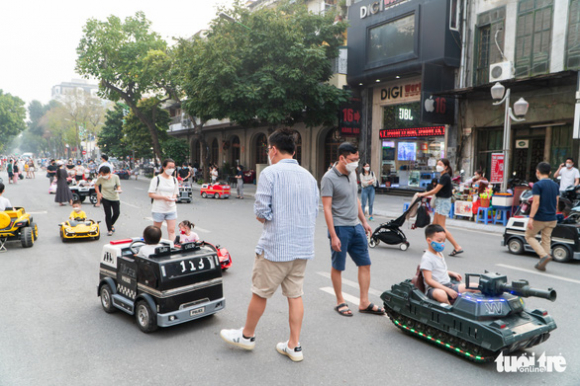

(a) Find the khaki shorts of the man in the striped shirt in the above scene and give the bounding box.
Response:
[252,253,308,299]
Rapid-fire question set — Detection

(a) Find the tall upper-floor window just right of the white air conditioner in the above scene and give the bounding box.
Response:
[515,0,553,77]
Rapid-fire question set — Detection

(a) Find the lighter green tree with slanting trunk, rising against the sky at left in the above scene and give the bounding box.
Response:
[76,12,167,163]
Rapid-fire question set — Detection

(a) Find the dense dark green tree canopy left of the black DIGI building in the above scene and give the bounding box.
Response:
[175,2,349,126]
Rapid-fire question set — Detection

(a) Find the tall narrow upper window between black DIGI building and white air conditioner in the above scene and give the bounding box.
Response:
[473,7,505,86]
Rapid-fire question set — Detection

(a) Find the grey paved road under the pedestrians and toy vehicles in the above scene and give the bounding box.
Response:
[0,178,580,386]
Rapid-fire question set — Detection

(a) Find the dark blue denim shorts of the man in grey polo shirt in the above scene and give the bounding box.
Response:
[328,224,371,271]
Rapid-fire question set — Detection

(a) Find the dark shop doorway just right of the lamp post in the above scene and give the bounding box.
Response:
[512,137,546,182]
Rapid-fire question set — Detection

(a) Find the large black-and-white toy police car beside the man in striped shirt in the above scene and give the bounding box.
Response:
[98,238,225,332]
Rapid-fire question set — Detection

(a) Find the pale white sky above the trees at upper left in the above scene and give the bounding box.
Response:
[0,0,233,106]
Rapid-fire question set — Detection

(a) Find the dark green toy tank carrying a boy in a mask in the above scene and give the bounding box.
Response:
[381,272,556,362]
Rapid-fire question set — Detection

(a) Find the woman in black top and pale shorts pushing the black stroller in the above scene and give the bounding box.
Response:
[417,158,463,256]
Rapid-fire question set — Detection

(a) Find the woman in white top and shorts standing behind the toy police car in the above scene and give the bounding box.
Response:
[149,159,179,240]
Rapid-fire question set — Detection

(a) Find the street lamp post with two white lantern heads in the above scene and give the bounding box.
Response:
[491,82,530,192]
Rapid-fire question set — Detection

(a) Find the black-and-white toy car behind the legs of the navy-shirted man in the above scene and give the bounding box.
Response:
[501,217,580,262]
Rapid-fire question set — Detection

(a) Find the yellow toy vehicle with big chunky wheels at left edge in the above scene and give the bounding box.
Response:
[0,207,38,252]
